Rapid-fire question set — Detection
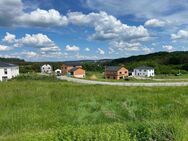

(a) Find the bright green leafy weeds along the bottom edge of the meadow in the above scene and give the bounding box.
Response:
[25,123,184,141]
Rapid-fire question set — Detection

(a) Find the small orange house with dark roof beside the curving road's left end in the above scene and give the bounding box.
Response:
[69,67,85,78]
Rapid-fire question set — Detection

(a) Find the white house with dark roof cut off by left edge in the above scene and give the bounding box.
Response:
[0,62,19,81]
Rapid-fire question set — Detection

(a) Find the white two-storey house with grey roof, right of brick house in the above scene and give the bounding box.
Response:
[132,66,155,77]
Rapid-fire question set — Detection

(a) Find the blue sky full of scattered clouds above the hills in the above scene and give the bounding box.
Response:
[0,0,188,61]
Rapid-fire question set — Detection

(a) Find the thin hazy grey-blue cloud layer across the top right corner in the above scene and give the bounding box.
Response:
[83,0,188,24]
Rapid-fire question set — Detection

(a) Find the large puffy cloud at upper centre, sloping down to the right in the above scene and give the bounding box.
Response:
[68,12,149,40]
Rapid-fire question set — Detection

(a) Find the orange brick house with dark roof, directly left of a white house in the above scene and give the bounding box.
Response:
[104,66,129,80]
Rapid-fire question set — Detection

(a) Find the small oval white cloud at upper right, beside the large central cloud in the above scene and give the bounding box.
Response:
[144,19,166,27]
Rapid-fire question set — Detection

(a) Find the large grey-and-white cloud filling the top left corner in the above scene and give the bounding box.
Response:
[0,0,68,27]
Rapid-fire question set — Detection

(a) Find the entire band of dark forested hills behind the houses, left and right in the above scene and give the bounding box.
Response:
[0,51,188,74]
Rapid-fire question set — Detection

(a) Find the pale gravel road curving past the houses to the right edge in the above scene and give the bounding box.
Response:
[57,76,188,87]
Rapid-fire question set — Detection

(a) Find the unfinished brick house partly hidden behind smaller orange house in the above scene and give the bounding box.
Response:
[61,62,82,75]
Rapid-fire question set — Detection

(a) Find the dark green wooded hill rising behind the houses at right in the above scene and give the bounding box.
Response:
[108,51,188,74]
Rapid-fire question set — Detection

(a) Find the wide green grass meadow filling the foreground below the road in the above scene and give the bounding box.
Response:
[0,77,188,141]
